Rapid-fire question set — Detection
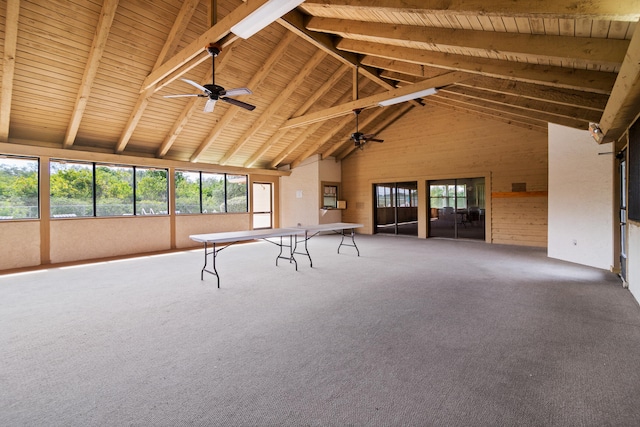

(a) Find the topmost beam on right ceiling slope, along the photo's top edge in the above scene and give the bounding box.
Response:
[302,0,640,22]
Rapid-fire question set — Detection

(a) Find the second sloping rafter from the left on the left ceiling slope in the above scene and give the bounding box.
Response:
[62,0,118,148]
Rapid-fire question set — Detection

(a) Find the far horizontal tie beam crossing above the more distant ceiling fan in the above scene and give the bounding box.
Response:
[281,71,469,128]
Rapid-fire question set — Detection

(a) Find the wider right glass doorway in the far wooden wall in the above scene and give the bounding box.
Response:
[427,178,486,240]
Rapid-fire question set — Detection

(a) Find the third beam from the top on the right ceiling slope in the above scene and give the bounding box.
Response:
[337,39,616,95]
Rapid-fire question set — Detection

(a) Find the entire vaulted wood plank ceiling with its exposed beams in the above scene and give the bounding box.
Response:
[0,0,640,169]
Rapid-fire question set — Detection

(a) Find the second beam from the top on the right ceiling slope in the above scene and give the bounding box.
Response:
[306,17,629,67]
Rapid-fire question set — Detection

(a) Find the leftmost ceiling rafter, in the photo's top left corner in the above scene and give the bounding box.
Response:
[0,0,20,141]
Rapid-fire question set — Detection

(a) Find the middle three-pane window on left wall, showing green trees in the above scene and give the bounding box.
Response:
[50,160,169,218]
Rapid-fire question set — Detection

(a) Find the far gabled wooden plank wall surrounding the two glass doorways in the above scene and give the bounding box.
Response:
[342,104,548,247]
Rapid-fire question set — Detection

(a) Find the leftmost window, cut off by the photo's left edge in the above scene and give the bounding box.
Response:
[0,157,39,219]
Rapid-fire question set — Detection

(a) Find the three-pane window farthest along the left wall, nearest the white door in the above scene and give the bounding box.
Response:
[175,171,249,214]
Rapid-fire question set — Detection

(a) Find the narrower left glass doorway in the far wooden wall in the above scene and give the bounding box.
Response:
[373,181,418,236]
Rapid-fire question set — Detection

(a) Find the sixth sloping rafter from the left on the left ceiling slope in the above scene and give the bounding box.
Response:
[218,50,327,165]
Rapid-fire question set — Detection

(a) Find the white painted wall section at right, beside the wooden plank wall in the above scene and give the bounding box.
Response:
[547,124,615,270]
